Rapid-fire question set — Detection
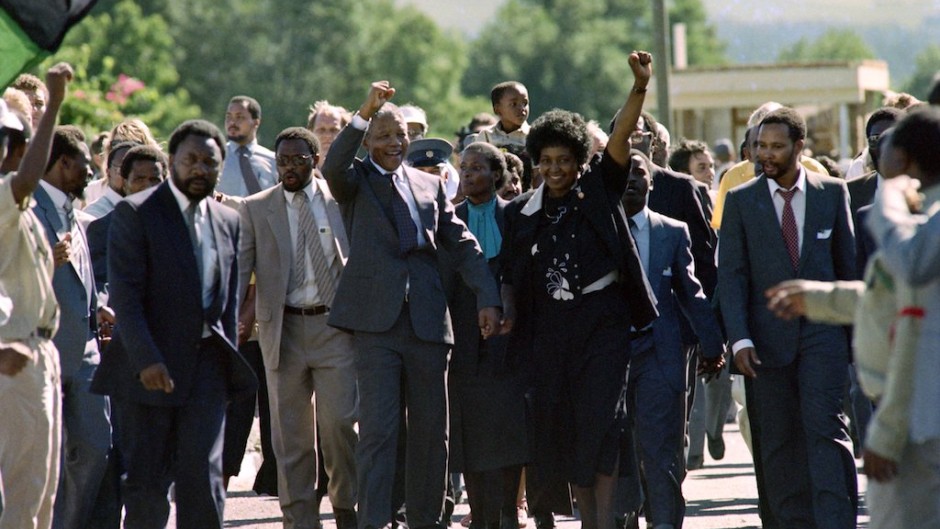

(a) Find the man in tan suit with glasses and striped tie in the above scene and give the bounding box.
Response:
[239,127,358,529]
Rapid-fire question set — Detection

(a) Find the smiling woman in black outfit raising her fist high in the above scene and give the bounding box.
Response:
[502,52,656,529]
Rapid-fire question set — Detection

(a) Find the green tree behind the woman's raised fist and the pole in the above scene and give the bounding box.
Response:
[463,0,724,124]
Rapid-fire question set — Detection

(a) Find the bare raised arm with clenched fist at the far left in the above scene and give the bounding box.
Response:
[11,62,74,204]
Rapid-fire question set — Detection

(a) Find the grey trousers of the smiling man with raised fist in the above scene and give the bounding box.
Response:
[355,305,450,529]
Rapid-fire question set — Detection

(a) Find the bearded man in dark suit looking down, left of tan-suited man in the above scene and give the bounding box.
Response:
[95,120,257,529]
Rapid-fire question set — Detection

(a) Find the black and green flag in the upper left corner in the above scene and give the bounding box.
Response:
[0,0,98,89]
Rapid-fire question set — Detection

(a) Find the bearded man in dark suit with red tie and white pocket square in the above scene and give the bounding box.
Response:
[718,108,858,529]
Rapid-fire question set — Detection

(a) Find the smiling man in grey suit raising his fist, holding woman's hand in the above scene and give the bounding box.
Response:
[323,81,501,529]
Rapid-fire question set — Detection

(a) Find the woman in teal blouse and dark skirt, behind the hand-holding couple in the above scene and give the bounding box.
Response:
[445,142,528,529]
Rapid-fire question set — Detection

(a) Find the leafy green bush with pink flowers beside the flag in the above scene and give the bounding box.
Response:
[39,0,200,137]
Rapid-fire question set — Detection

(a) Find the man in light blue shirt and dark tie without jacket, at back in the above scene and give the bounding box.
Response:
[216,96,277,197]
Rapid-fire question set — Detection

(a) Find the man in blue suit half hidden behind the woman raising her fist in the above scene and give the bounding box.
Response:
[623,150,724,529]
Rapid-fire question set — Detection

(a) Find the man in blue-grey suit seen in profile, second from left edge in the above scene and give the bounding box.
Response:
[33,125,111,528]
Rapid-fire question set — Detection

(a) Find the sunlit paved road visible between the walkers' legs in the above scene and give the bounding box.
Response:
[168,421,868,529]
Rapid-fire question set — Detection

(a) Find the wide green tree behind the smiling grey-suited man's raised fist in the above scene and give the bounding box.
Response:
[166,0,471,143]
